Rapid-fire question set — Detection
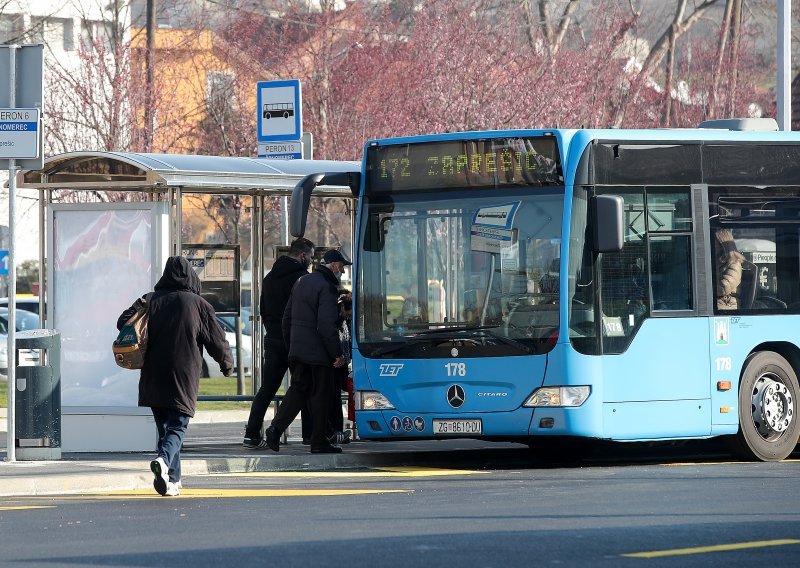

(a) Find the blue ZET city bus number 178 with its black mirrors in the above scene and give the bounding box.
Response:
[292,120,800,461]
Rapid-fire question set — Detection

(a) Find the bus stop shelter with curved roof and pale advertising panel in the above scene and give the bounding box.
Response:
[17,152,360,452]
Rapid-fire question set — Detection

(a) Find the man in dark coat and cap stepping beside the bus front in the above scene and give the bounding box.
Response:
[264,250,352,454]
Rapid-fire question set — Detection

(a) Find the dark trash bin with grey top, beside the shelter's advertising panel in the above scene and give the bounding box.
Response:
[14,329,61,460]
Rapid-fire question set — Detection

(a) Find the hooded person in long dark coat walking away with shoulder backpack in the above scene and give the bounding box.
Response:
[117,256,233,495]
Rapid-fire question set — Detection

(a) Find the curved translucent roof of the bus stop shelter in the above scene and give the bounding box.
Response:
[18,152,361,197]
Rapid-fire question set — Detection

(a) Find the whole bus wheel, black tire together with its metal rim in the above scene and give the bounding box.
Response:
[729,351,800,461]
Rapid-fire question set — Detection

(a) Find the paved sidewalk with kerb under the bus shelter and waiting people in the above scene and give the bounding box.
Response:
[0,411,529,497]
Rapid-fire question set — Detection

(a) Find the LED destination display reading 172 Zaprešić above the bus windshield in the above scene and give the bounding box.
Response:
[367,136,564,193]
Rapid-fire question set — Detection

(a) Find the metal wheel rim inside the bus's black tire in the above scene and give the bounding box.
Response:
[750,373,795,442]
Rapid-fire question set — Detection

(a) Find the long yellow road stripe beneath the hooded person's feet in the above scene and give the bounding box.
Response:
[58,488,413,499]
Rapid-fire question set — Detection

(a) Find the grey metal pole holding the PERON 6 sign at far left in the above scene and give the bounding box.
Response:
[6,45,19,462]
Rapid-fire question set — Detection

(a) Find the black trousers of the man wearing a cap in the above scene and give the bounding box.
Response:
[272,361,333,449]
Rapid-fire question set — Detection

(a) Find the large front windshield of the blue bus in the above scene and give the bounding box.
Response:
[356,191,564,358]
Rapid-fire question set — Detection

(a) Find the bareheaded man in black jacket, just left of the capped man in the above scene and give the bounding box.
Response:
[242,237,314,450]
